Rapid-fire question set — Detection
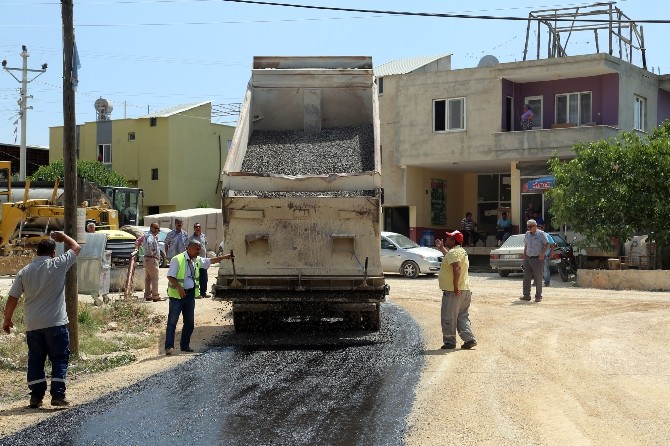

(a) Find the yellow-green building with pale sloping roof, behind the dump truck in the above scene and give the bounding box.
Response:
[49,102,235,220]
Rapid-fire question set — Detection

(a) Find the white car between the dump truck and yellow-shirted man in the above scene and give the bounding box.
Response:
[381,232,443,279]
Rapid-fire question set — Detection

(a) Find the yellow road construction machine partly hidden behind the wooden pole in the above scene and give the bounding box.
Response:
[0,161,119,274]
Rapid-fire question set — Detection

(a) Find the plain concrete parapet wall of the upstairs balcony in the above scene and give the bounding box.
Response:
[493,125,620,159]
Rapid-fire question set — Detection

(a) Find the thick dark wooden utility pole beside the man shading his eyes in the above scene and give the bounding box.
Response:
[61,0,79,356]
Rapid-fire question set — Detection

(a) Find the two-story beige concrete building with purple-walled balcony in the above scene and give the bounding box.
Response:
[375,53,670,246]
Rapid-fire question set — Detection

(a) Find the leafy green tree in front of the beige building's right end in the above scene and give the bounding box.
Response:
[547,121,670,256]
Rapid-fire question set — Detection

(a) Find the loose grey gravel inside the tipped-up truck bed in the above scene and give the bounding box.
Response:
[236,125,374,197]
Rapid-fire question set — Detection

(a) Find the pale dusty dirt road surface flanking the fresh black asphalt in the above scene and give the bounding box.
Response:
[0,270,670,446]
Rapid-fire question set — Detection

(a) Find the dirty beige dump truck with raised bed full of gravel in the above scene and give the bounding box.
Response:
[212,56,389,331]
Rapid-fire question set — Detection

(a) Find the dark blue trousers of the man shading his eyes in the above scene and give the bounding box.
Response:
[26,325,70,398]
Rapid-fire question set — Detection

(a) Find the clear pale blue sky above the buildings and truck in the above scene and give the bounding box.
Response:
[0,0,670,150]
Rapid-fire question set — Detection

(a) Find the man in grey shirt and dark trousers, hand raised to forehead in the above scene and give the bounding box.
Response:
[2,232,81,409]
